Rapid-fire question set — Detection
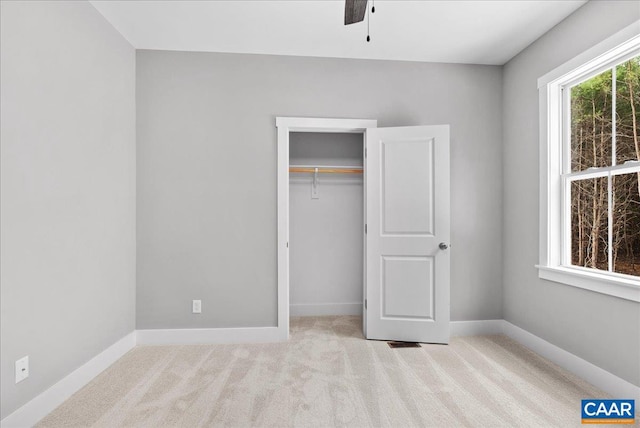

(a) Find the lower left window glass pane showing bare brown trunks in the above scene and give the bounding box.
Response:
[571,177,609,270]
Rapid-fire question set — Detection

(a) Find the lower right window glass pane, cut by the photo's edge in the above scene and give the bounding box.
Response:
[612,173,640,276]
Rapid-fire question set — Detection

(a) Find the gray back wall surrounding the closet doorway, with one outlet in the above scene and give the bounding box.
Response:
[137,51,502,329]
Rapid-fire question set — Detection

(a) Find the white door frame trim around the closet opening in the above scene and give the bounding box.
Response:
[276,117,378,340]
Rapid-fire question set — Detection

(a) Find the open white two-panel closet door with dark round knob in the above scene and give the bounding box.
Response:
[365,125,450,343]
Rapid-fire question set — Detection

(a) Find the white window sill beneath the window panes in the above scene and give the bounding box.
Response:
[536,265,640,302]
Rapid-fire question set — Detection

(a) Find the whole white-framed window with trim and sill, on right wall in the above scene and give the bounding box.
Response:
[538,23,640,302]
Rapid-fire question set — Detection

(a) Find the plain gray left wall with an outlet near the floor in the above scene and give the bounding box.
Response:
[0,1,135,418]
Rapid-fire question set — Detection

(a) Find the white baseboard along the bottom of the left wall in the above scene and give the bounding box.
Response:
[0,331,136,428]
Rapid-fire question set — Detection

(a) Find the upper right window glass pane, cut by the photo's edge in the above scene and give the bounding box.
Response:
[616,56,640,164]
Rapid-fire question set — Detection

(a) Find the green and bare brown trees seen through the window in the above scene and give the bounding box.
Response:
[563,56,640,276]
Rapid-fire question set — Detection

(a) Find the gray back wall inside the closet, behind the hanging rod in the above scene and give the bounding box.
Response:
[289,132,364,315]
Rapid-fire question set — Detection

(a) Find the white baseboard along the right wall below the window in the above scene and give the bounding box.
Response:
[502,320,640,408]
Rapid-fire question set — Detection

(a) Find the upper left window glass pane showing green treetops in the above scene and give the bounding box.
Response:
[571,70,612,171]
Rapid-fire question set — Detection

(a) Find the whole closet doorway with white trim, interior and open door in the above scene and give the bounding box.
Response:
[276,117,450,343]
